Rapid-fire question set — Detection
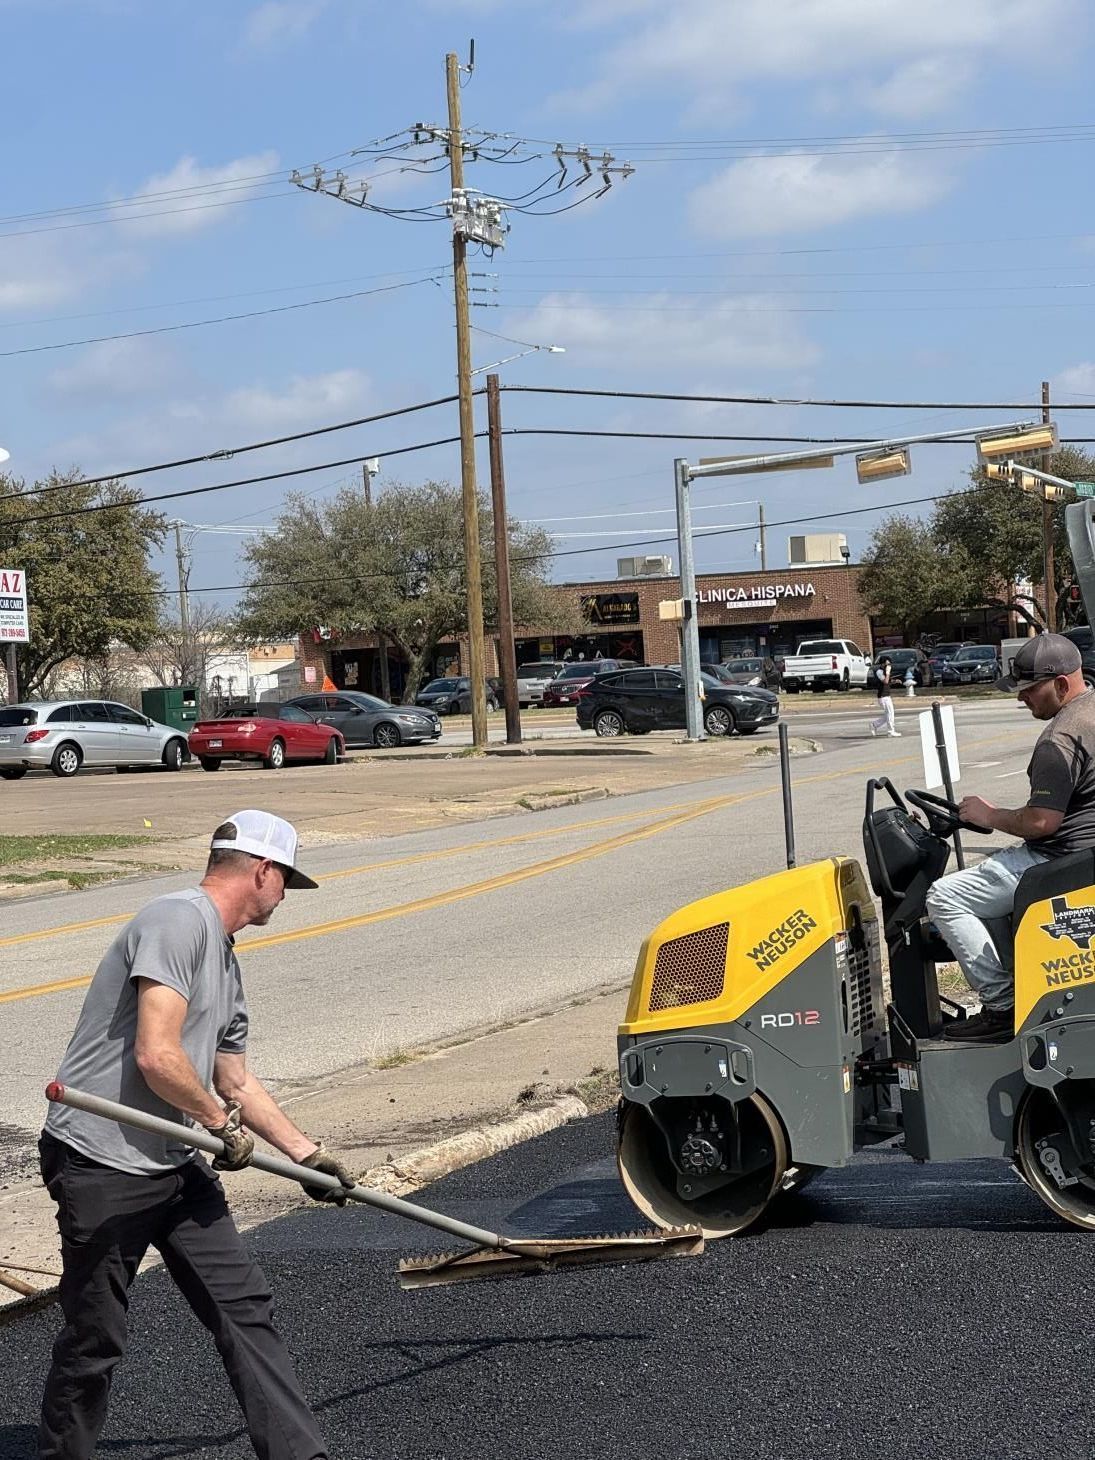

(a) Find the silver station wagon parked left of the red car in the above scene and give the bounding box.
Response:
[0,699,190,781]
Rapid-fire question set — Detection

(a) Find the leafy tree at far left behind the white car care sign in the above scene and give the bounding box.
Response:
[0,470,165,696]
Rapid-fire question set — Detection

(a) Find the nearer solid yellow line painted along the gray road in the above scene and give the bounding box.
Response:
[0,721,1039,1003]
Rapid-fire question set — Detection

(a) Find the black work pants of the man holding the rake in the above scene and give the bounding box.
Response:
[38,1134,327,1460]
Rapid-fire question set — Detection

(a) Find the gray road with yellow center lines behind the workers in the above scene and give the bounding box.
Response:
[0,701,1038,1175]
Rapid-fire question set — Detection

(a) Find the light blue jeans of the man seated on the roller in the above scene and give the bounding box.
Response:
[924,845,1048,1009]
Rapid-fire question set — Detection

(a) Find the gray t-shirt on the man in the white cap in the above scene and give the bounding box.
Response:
[45,888,247,1174]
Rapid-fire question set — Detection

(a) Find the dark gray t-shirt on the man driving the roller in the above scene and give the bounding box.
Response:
[1026,691,1095,857]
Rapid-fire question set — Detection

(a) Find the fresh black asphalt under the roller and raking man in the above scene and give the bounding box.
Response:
[0,1117,1095,1460]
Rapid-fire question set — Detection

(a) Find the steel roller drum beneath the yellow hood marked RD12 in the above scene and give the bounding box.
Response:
[616,1095,788,1237]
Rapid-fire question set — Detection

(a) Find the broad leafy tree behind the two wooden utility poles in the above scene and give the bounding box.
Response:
[239,482,572,701]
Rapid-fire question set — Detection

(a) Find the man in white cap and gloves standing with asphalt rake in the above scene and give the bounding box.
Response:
[38,810,353,1460]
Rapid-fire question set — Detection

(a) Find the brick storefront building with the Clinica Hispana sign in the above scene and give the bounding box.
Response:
[293,566,873,696]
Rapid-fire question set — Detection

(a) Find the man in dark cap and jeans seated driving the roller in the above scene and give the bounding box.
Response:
[926,634,1095,1044]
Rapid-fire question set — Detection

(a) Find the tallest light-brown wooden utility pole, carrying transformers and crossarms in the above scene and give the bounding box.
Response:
[445,51,486,748]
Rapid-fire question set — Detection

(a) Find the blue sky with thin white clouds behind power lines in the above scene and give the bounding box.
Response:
[0,0,1095,599]
